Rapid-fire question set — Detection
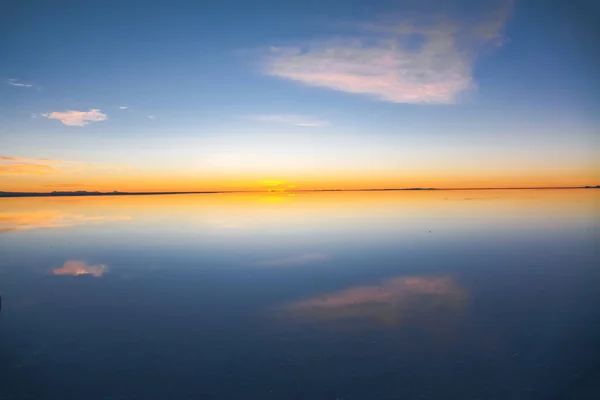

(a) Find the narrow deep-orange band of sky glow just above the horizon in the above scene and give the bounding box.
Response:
[0,171,600,192]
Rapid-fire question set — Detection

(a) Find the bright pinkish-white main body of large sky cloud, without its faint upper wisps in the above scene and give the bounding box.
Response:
[268,39,472,104]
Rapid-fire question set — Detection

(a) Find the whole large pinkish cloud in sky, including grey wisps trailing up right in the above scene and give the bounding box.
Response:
[264,7,509,104]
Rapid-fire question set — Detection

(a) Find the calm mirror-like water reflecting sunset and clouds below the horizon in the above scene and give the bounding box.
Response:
[0,190,600,400]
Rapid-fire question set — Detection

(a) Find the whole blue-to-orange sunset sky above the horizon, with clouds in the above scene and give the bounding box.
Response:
[0,0,600,191]
